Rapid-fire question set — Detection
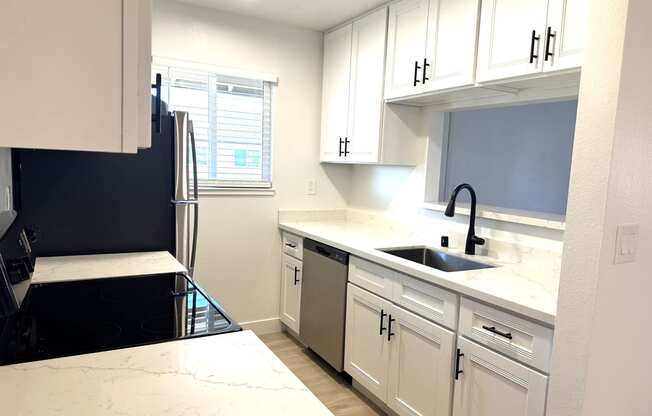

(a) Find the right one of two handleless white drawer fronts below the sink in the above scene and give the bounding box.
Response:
[392,273,459,329]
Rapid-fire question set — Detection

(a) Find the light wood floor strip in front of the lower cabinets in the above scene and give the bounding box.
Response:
[261,333,384,416]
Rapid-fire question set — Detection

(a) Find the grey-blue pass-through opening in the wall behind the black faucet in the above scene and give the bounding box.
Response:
[426,101,577,217]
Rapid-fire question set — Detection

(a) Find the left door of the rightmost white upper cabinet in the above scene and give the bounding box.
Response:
[476,0,548,82]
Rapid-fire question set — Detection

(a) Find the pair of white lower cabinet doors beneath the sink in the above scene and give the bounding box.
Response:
[344,284,455,416]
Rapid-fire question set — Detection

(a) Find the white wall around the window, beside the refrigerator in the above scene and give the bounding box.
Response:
[153,0,350,332]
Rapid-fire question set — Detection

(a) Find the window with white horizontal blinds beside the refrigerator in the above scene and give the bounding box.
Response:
[153,61,273,189]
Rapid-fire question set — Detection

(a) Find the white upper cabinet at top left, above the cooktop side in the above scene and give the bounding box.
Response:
[0,0,151,153]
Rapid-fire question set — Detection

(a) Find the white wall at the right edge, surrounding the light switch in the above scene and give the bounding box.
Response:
[548,0,652,416]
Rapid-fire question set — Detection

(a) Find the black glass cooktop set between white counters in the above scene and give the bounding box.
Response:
[0,274,240,365]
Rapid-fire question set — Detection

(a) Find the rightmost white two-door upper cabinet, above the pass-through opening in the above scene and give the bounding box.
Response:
[477,0,589,83]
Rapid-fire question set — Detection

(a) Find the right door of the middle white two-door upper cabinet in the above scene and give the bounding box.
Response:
[425,0,480,91]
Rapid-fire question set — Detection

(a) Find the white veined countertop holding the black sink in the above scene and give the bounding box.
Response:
[279,220,558,326]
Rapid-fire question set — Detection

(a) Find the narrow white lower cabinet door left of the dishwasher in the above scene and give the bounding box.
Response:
[281,254,302,334]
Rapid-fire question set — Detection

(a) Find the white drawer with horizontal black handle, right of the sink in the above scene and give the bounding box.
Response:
[460,298,553,373]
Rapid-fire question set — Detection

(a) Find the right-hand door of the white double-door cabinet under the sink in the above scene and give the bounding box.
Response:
[388,307,455,416]
